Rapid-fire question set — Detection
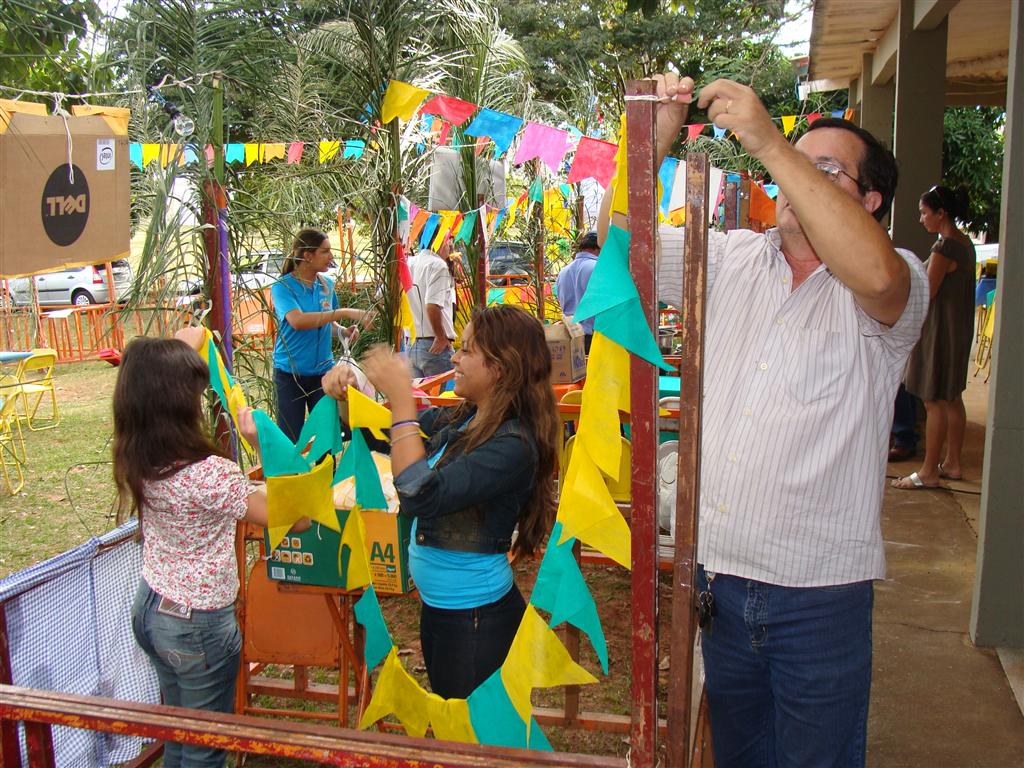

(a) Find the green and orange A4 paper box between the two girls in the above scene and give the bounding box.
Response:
[263,509,413,595]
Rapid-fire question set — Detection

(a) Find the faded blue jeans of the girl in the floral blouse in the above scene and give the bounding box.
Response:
[131,581,242,768]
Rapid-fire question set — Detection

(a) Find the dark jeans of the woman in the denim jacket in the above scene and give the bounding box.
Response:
[420,584,526,698]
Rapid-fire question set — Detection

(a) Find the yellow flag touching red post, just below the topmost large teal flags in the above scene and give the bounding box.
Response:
[575,333,630,480]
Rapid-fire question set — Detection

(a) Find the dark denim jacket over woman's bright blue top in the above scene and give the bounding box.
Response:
[394,408,538,554]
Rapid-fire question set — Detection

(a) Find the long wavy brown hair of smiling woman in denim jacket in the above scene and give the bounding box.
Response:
[455,304,561,555]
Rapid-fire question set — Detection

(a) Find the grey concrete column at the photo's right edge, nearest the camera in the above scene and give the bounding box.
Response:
[971,3,1024,648]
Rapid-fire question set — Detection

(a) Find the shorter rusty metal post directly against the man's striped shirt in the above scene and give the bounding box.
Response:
[668,153,708,768]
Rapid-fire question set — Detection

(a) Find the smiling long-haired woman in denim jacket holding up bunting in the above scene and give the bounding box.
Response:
[324,305,559,698]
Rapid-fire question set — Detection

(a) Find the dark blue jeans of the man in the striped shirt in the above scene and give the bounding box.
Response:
[697,566,874,768]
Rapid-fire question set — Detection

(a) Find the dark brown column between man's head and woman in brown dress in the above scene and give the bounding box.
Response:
[892,0,947,258]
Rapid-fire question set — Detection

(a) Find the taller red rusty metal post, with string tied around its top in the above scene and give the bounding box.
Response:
[626,80,658,768]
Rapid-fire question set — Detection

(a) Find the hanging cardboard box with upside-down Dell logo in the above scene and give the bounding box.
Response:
[0,99,131,278]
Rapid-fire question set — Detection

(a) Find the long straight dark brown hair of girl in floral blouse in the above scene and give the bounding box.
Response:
[114,337,223,521]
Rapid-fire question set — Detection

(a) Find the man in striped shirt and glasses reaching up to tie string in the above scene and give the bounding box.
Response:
[602,75,928,768]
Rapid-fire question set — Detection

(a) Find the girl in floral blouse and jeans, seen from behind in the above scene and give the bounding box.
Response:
[114,328,294,768]
